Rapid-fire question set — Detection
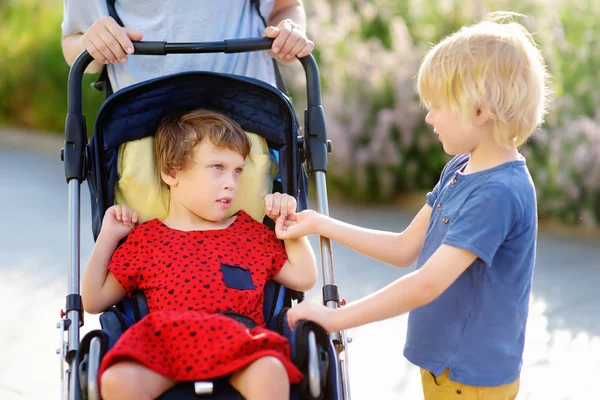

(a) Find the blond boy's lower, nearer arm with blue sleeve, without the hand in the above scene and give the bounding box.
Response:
[326,182,524,329]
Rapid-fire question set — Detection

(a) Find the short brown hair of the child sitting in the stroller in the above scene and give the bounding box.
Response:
[154,110,251,175]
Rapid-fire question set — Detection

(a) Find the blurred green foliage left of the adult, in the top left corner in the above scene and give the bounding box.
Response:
[0,0,104,132]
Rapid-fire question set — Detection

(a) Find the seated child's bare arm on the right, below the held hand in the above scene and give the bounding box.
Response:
[273,237,317,292]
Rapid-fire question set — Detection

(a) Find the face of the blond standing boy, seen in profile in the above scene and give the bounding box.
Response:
[425,104,481,155]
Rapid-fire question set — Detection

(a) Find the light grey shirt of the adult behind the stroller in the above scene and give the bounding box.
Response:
[62,0,275,91]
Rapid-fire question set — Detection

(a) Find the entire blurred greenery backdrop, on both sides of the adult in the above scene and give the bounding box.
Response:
[0,0,600,227]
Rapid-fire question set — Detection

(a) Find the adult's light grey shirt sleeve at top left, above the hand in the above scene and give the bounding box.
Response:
[61,0,108,36]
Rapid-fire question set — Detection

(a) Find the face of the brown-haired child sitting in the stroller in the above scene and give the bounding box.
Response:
[169,139,244,221]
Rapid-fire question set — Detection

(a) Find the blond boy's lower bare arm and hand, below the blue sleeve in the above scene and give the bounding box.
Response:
[288,244,477,332]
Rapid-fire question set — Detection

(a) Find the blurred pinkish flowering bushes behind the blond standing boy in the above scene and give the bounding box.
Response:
[294,0,600,224]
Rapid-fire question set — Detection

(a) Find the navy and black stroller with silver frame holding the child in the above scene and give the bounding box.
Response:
[57,38,350,400]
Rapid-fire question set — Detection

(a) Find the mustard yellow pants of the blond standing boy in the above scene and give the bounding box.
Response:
[421,368,519,400]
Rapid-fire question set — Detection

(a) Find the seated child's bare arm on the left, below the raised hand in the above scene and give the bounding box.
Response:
[81,233,126,314]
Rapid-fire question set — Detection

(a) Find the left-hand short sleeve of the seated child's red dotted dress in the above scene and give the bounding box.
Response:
[108,227,150,293]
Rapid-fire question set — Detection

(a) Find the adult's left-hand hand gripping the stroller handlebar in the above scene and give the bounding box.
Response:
[81,16,142,64]
